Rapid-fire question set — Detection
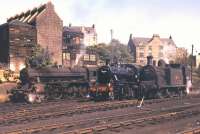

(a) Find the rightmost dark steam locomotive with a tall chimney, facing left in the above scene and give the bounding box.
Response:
[139,56,190,98]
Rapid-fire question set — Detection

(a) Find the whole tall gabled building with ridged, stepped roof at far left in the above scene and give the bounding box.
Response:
[0,2,63,71]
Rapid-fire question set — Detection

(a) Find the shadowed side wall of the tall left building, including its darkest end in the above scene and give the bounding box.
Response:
[0,20,36,72]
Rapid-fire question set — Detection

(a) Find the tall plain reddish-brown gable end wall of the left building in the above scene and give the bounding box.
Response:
[36,2,63,65]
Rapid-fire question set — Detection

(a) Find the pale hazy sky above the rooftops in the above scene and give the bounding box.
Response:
[0,0,200,53]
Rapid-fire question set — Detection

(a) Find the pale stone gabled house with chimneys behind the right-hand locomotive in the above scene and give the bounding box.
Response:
[128,34,176,65]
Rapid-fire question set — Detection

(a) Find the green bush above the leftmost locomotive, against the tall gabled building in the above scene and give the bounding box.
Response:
[27,45,52,68]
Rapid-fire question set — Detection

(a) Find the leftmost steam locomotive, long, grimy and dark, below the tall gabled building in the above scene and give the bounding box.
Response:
[10,67,96,102]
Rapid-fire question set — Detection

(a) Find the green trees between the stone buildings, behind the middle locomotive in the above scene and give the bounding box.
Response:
[87,40,133,63]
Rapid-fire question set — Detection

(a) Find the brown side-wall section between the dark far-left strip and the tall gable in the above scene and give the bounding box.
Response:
[9,22,36,72]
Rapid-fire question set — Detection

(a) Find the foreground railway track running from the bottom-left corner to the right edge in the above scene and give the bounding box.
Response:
[5,100,200,134]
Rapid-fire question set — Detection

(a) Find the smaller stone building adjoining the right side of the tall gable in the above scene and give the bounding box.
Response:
[62,27,97,66]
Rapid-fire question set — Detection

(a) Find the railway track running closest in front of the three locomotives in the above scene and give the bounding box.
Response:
[0,94,199,126]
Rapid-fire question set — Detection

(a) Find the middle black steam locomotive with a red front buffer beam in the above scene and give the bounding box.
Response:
[90,64,139,100]
